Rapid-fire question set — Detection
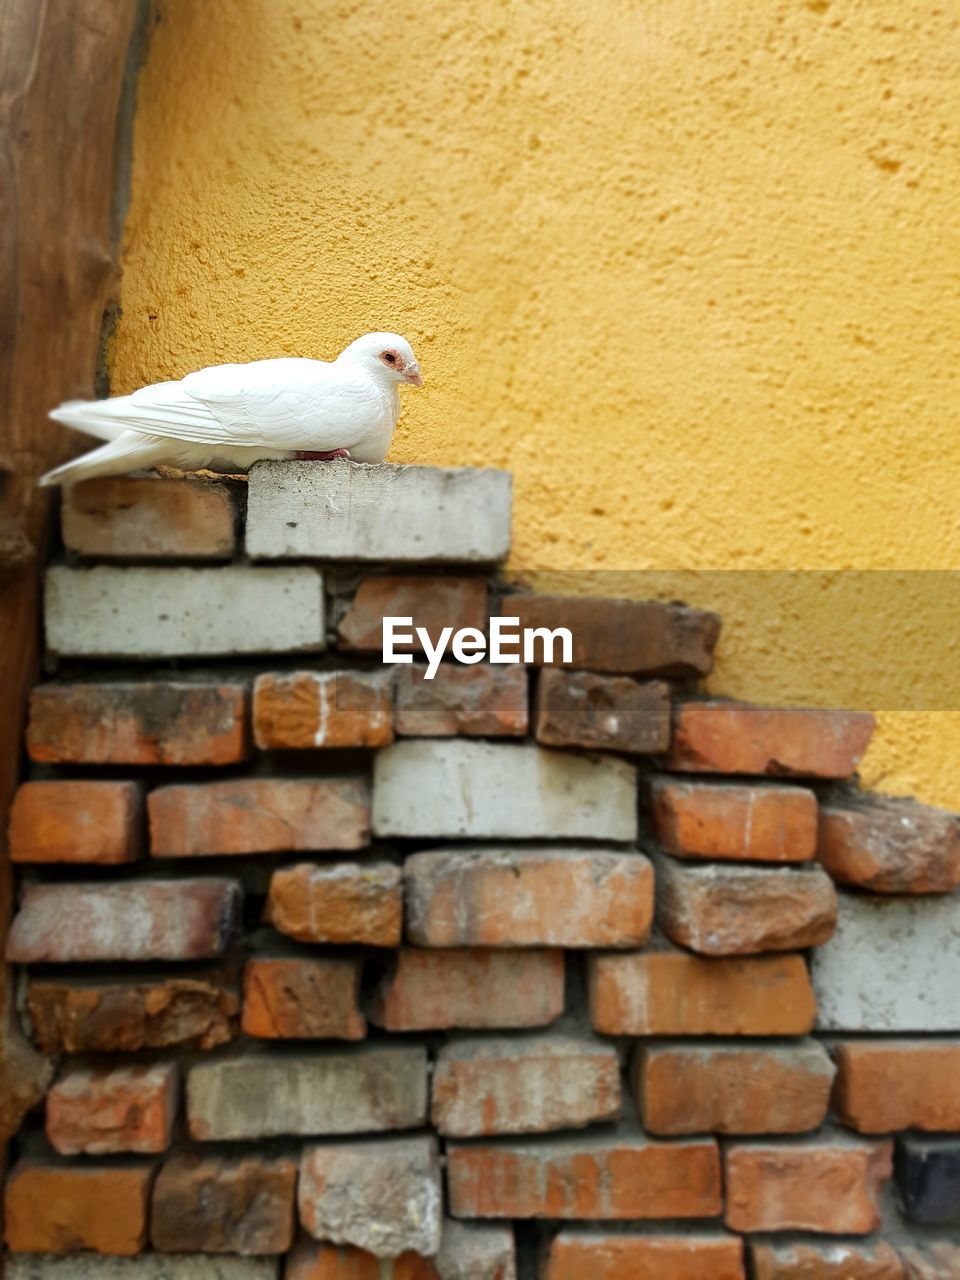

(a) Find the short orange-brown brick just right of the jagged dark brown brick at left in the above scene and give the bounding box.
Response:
[243,956,366,1041]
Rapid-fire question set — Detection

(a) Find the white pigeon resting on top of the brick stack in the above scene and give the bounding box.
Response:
[40,333,424,485]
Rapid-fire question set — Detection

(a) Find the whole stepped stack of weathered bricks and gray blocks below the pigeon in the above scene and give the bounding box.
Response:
[5,463,960,1280]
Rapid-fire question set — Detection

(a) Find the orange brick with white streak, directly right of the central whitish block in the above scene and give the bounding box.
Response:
[649,776,817,863]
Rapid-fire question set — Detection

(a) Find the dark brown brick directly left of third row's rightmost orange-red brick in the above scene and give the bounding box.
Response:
[534,667,671,755]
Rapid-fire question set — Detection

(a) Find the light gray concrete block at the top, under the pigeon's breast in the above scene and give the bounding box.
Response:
[247,461,511,564]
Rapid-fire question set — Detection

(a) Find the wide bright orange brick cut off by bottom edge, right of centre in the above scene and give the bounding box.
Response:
[540,1228,746,1280]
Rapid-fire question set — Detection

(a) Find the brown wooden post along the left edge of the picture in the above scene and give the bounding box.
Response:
[0,0,137,1144]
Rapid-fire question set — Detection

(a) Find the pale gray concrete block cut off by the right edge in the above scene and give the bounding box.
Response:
[810,893,960,1032]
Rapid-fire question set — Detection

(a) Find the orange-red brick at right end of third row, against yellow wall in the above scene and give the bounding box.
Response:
[666,701,874,778]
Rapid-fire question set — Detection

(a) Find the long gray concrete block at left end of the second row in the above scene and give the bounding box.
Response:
[44,564,325,658]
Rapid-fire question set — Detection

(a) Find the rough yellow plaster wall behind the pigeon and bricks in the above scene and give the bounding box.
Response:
[113,0,960,808]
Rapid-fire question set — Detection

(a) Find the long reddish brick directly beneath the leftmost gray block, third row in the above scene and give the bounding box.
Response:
[27,680,250,764]
